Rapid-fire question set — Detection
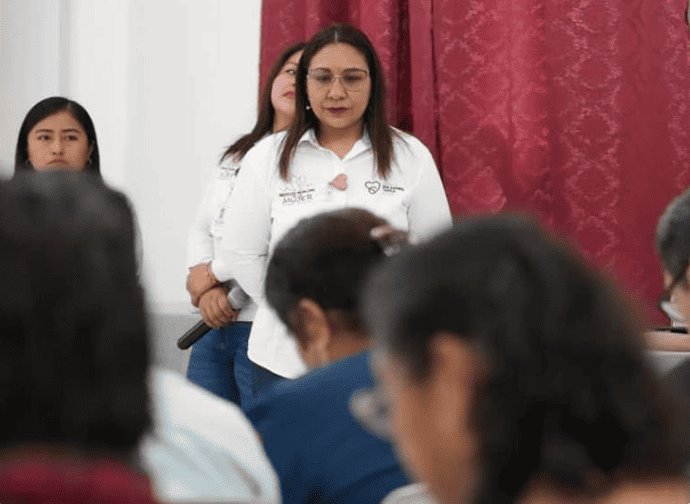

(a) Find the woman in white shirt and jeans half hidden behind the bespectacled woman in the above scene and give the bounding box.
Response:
[187,43,304,409]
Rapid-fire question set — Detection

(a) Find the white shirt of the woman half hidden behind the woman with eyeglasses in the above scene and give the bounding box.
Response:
[187,159,257,321]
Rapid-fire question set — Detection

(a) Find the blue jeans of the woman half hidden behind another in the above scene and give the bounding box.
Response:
[187,322,254,411]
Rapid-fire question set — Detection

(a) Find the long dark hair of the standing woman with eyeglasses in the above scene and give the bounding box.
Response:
[279,23,394,180]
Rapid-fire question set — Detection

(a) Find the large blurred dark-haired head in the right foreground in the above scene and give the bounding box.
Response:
[363,216,688,503]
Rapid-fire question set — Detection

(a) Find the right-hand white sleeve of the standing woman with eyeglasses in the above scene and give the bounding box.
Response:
[407,139,452,243]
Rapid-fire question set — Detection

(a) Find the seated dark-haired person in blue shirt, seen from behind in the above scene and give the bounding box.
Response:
[249,209,408,504]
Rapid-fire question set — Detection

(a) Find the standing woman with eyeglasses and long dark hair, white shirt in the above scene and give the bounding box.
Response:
[185,24,451,379]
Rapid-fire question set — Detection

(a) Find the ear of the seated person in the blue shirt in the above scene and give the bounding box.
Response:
[295,298,332,368]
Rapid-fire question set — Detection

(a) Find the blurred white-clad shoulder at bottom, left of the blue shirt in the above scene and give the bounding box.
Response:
[140,367,279,502]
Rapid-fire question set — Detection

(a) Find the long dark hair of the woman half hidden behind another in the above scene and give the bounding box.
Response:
[220,42,305,162]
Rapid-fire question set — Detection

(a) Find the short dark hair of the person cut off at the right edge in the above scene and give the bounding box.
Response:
[656,189,690,285]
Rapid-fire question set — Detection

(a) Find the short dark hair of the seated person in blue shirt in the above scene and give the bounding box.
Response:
[265,208,399,331]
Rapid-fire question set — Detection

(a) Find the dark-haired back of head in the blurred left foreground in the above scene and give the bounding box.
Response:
[0,172,150,455]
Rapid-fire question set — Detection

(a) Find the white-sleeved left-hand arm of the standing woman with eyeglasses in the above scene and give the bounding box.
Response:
[211,138,275,299]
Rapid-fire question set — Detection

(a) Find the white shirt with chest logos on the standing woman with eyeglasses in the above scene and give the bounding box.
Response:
[211,130,451,378]
